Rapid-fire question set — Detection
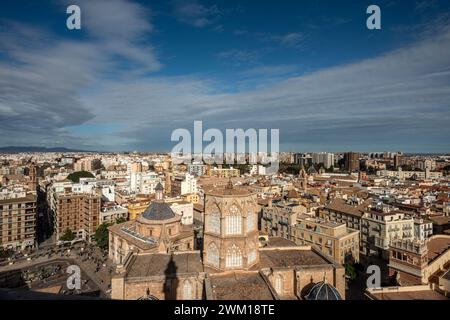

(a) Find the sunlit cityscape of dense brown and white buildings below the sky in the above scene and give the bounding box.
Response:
[0,152,450,300]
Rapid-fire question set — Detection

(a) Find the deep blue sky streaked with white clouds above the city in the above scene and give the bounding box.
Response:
[0,0,450,153]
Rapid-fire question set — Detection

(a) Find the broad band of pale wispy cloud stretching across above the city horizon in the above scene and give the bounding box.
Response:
[0,0,450,151]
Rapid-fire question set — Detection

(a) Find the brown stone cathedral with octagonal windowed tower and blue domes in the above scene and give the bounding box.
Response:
[110,183,345,300]
